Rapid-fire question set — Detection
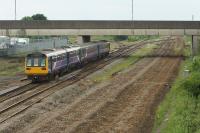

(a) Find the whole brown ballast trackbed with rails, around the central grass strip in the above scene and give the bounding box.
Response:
[0,38,184,133]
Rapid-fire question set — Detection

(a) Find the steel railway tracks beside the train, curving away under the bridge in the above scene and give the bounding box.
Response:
[0,37,175,123]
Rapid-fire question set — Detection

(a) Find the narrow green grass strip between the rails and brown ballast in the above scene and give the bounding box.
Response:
[93,44,157,82]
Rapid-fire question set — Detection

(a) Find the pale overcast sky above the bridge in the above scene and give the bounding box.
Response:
[0,0,200,20]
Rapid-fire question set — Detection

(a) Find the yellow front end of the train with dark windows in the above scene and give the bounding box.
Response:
[25,54,49,82]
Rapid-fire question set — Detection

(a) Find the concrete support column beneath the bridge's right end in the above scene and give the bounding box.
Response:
[192,35,200,56]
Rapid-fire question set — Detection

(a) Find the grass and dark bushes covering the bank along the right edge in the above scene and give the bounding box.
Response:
[153,37,200,133]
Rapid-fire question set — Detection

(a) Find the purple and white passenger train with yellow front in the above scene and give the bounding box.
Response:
[25,41,110,82]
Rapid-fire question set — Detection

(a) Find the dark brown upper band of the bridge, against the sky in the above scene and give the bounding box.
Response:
[0,20,200,29]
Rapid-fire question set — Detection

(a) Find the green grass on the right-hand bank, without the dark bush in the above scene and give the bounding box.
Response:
[153,60,200,133]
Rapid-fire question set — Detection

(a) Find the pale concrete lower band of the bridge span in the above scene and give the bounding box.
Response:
[0,29,200,36]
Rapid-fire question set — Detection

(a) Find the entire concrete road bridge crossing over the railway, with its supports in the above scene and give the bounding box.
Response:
[0,20,200,54]
